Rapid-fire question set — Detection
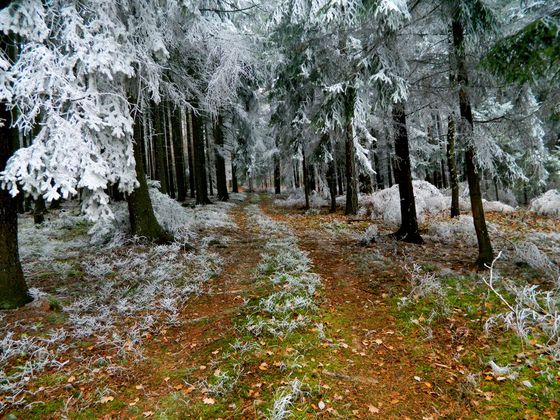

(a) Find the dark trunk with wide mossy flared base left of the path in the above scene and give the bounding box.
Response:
[127,114,174,244]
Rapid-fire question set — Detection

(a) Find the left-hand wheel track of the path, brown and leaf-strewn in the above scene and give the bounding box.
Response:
[96,197,268,419]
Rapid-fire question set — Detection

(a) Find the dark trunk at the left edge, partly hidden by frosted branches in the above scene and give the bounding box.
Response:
[0,35,32,310]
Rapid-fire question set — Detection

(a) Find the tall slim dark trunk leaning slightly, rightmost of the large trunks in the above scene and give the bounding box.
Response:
[452,19,494,268]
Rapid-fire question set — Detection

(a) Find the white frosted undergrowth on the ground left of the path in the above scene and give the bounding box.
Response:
[0,189,238,411]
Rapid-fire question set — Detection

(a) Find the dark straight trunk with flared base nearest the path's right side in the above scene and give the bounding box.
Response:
[393,102,424,244]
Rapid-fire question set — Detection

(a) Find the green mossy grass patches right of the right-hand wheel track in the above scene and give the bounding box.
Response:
[391,270,560,419]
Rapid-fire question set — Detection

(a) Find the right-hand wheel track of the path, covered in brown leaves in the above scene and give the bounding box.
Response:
[264,201,471,419]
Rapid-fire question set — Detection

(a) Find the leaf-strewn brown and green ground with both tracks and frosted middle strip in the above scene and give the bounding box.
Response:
[0,195,560,419]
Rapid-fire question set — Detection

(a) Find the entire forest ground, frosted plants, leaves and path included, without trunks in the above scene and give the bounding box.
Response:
[0,192,560,419]
